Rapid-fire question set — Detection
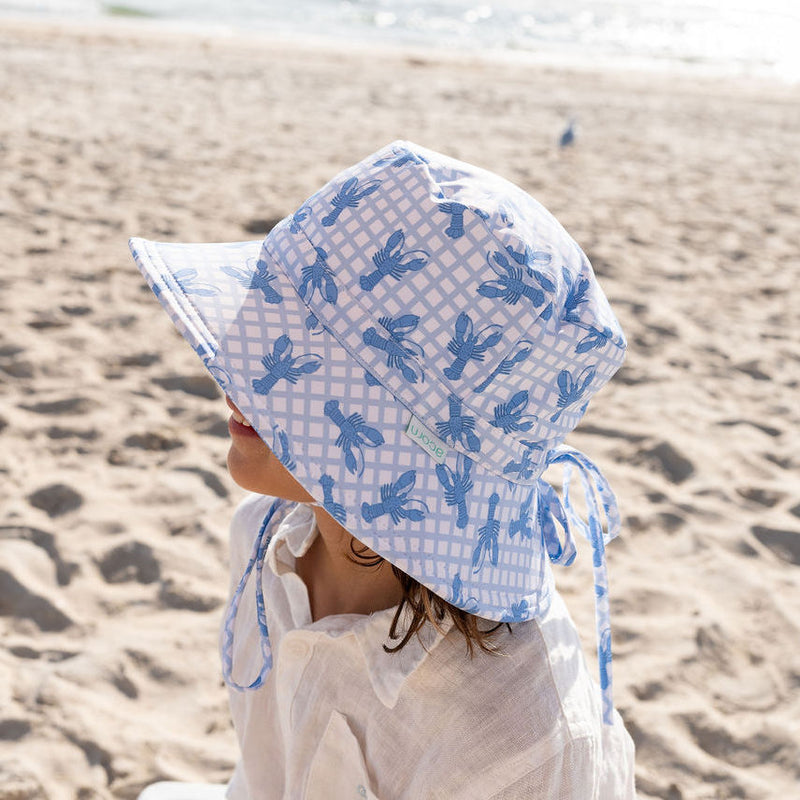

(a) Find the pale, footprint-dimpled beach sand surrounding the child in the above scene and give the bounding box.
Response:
[0,18,800,800]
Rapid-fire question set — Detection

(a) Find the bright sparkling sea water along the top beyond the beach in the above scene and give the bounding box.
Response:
[0,0,800,82]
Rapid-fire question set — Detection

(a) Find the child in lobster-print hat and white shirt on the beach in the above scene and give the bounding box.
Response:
[131,142,634,800]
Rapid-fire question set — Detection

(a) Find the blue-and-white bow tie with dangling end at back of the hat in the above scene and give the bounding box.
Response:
[539,445,620,725]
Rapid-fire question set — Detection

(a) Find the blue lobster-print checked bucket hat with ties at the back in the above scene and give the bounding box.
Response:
[131,141,626,718]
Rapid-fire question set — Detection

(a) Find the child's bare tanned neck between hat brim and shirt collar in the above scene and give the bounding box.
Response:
[297,508,402,621]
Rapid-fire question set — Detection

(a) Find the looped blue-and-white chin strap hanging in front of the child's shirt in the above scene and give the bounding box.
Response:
[221,500,284,692]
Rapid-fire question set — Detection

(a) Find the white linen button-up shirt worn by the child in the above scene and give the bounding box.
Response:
[222,495,635,800]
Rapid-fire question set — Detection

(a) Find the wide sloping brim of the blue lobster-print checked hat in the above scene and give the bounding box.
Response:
[130,228,552,620]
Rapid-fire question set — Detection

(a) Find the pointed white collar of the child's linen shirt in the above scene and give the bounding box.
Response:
[267,503,453,708]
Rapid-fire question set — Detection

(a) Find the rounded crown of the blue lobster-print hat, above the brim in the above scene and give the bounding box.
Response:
[265,141,625,483]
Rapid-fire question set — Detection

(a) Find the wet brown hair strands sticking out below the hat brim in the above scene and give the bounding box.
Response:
[350,539,511,658]
